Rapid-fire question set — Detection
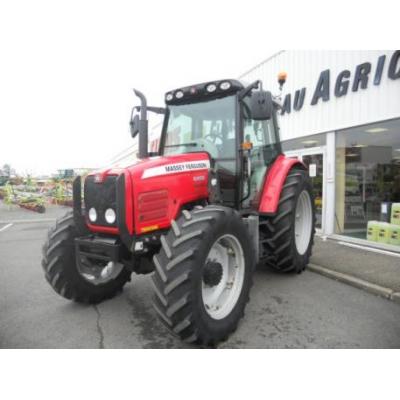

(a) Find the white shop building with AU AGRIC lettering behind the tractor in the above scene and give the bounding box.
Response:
[240,50,400,250]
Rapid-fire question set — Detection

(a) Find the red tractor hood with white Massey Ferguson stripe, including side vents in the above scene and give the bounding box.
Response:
[84,152,211,235]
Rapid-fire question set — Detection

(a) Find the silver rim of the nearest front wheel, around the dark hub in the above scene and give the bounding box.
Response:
[202,235,245,319]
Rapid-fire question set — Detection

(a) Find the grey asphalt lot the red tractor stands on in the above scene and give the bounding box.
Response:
[0,203,400,348]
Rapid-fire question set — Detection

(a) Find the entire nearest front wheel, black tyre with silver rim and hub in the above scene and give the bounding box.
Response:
[152,205,254,346]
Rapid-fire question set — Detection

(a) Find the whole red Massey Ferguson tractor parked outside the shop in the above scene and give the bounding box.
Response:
[42,76,315,345]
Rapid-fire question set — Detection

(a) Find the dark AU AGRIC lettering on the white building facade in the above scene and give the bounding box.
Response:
[281,50,400,115]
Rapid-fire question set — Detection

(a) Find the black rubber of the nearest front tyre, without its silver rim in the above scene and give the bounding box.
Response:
[152,205,255,346]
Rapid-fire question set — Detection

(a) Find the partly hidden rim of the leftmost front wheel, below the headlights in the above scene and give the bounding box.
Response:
[78,257,124,285]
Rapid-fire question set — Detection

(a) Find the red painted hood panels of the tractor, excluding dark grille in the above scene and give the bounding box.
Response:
[88,152,210,234]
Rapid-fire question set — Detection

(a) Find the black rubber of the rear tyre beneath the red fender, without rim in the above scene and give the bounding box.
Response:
[260,168,315,273]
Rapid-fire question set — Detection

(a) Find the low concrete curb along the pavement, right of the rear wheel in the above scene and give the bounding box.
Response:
[308,264,400,304]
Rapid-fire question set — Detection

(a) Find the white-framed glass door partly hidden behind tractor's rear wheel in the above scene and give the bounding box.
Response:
[286,147,325,232]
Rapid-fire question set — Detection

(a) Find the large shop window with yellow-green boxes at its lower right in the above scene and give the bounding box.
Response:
[335,119,400,246]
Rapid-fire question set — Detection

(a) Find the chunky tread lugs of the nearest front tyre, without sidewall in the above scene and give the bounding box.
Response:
[152,205,252,346]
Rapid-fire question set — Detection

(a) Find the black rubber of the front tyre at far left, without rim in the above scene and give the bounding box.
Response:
[42,211,131,304]
